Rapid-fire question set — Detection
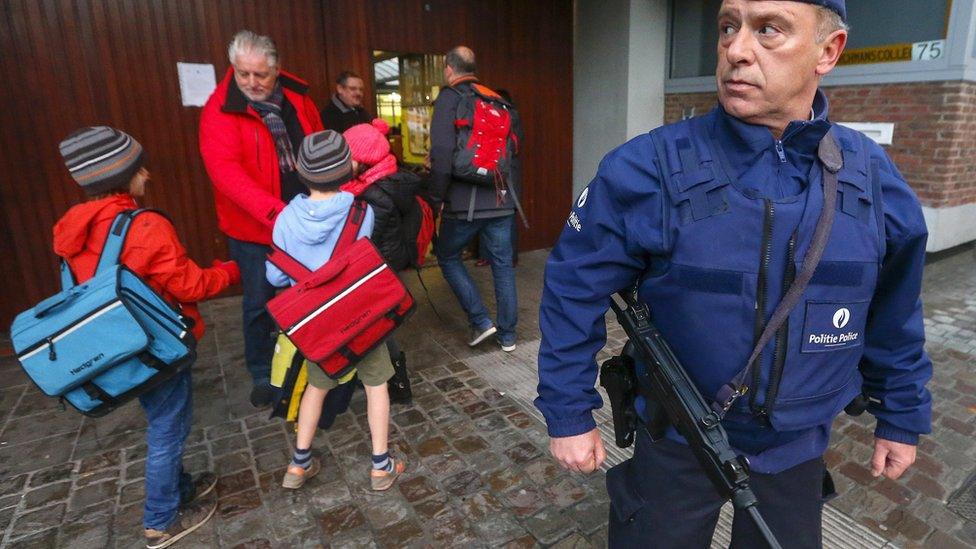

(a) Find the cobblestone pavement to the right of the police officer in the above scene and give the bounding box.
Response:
[825,248,976,549]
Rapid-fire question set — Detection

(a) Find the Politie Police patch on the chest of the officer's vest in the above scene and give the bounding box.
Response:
[800,301,871,353]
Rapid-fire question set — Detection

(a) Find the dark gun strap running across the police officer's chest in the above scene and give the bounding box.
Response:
[712,132,844,417]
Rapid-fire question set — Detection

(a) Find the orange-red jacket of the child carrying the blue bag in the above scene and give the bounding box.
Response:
[54,194,230,340]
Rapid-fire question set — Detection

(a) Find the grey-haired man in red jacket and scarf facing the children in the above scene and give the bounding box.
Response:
[200,30,323,407]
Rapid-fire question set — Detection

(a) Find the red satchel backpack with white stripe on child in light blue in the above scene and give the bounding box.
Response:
[267,200,415,379]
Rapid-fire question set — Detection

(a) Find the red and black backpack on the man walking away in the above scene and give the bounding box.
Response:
[452,82,518,187]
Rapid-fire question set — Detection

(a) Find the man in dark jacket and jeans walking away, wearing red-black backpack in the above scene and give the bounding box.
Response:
[430,46,518,352]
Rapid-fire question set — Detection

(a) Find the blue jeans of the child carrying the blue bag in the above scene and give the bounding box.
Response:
[139,368,193,530]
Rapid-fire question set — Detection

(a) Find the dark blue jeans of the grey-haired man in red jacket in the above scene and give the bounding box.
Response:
[227,237,277,385]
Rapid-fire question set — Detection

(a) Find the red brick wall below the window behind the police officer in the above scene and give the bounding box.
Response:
[664,82,976,208]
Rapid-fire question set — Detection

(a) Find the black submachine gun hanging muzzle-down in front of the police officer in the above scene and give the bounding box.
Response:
[600,293,781,549]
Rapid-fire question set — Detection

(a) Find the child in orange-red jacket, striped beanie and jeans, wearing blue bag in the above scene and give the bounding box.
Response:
[54,126,240,549]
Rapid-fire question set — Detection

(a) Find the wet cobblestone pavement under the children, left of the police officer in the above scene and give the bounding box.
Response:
[0,253,609,548]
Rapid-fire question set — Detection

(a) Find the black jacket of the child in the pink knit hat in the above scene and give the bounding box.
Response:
[359,171,423,271]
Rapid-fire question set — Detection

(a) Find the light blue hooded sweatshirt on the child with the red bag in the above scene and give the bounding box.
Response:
[265,191,373,287]
